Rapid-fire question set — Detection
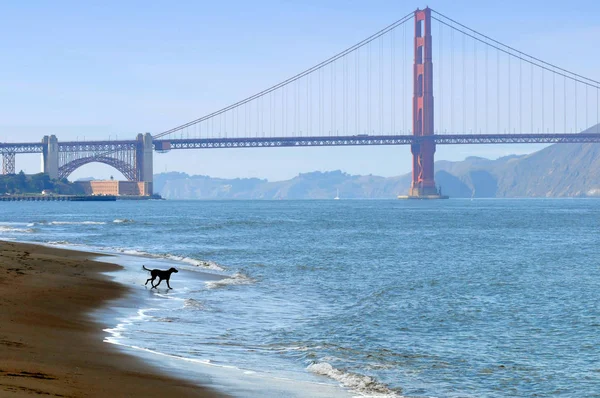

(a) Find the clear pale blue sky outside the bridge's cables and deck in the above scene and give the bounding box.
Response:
[0,0,600,180]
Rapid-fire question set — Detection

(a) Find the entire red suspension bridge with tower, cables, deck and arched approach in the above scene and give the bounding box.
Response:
[0,8,600,198]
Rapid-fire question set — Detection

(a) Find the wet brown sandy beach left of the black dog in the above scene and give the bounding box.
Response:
[0,242,223,397]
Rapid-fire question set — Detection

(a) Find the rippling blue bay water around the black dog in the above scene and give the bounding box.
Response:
[0,199,600,397]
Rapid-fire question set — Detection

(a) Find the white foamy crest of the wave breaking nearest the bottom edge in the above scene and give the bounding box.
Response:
[306,362,400,398]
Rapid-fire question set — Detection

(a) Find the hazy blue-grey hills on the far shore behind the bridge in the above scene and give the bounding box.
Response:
[154,137,600,199]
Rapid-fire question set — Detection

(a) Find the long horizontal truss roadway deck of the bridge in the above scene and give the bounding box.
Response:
[0,132,600,154]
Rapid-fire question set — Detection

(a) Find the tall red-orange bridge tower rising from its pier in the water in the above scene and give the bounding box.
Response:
[404,7,445,199]
